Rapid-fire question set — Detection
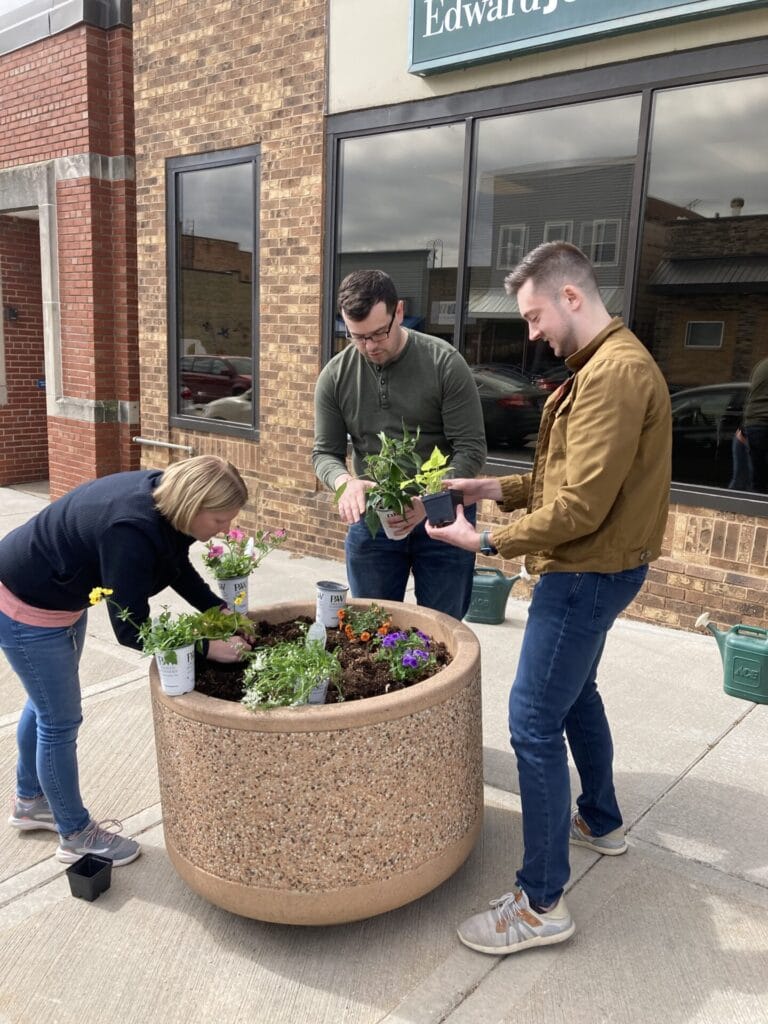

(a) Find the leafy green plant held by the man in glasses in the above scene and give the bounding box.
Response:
[334,425,422,537]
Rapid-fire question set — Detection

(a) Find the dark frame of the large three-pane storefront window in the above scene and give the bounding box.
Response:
[322,39,768,518]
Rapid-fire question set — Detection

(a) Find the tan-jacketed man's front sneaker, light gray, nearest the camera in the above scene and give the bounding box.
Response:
[459,889,575,956]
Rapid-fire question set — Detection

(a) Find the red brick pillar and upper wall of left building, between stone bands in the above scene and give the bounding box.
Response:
[0,26,139,497]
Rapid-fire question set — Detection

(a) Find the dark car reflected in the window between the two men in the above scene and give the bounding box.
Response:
[470,367,546,445]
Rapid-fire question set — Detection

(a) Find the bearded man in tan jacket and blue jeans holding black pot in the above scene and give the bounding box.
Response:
[427,242,672,954]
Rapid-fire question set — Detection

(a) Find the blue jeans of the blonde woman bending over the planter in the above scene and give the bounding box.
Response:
[0,611,90,836]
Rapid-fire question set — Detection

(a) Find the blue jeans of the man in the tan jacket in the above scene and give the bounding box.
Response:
[509,565,648,906]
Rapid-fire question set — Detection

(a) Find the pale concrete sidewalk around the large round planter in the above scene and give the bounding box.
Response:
[0,487,768,1024]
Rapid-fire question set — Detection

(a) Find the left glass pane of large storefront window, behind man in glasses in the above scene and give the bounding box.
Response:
[334,124,464,351]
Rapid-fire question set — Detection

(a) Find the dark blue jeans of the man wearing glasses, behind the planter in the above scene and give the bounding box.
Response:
[344,505,477,618]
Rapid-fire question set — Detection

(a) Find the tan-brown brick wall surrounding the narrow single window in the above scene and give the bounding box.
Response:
[133,0,327,532]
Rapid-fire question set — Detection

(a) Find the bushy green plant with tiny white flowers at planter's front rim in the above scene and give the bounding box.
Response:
[242,622,341,711]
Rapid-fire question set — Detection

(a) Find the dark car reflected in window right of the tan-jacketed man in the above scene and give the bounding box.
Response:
[671,381,750,487]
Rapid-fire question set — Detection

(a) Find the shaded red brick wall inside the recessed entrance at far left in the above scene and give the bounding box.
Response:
[0,217,48,485]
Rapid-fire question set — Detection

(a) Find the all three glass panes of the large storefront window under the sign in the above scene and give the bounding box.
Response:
[334,66,768,501]
